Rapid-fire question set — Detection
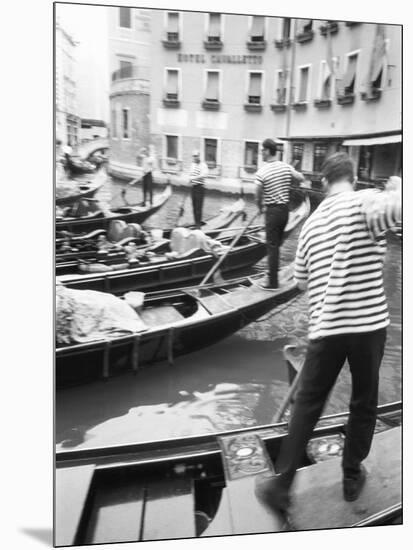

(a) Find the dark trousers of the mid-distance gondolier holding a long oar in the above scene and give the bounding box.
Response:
[265,204,288,287]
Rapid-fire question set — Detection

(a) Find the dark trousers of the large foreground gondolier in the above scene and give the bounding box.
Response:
[275,328,386,492]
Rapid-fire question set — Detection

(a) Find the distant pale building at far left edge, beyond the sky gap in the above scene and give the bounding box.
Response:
[55,20,80,147]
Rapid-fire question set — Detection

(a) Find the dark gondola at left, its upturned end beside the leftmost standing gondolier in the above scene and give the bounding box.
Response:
[56,185,172,234]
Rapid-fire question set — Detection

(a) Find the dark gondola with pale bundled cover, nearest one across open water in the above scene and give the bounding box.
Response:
[56,266,299,389]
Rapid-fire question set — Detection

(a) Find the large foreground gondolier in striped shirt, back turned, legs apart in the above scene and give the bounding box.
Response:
[255,153,401,512]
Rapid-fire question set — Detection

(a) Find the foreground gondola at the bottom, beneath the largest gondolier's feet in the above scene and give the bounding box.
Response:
[55,384,402,546]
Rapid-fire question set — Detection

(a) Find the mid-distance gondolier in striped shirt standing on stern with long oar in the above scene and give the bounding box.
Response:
[255,139,304,288]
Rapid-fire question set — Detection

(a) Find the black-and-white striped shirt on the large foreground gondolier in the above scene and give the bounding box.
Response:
[294,189,401,340]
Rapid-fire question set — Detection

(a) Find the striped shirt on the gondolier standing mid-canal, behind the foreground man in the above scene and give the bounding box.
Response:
[255,160,292,205]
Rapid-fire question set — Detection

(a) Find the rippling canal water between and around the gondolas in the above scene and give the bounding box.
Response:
[55,181,402,450]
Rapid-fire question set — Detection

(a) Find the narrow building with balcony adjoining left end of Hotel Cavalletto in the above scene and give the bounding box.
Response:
[108,7,151,177]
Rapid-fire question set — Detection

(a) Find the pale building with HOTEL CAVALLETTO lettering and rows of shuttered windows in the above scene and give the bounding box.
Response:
[105,10,401,188]
